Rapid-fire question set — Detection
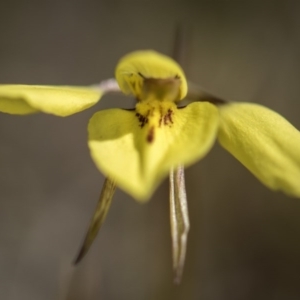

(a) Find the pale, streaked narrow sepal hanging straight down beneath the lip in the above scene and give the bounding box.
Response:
[170,166,190,284]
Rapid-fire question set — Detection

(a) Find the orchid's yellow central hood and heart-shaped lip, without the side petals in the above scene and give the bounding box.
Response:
[88,51,219,201]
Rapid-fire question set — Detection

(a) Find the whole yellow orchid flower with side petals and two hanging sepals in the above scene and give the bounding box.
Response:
[0,51,300,281]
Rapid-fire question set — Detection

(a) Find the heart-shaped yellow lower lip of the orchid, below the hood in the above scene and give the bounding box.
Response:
[88,102,219,200]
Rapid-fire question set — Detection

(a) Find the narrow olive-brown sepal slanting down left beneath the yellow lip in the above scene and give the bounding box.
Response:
[74,178,116,264]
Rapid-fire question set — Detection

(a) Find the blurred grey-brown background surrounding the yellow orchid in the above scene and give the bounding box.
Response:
[0,0,300,300]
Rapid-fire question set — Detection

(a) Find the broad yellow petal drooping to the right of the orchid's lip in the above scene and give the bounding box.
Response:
[218,103,300,197]
